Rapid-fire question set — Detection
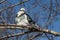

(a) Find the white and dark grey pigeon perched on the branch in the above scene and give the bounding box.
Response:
[15,8,38,25]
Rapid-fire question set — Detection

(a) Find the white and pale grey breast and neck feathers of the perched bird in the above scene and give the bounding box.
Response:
[15,11,29,25]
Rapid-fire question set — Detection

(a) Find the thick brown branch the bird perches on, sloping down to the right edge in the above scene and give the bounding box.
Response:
[0,24,60,36]
